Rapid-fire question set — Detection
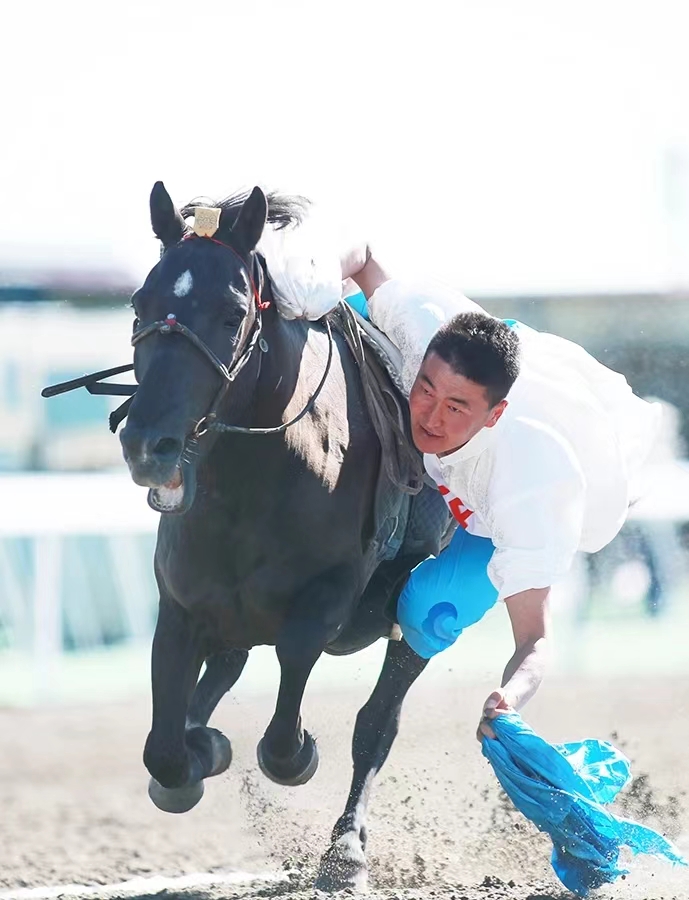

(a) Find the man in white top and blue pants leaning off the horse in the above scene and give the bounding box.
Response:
[262,232,659,737]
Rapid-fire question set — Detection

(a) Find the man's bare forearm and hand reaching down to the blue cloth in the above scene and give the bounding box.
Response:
[477,587,550,740]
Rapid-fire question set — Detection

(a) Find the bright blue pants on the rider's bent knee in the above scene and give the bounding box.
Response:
[397,528,498,659]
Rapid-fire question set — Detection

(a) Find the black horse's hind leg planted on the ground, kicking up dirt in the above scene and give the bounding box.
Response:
[316,641,428,891]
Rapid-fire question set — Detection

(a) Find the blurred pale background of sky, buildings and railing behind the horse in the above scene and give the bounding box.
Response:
[0,0,689,705]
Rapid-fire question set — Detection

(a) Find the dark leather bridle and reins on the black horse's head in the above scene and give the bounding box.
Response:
[41,234,333,441]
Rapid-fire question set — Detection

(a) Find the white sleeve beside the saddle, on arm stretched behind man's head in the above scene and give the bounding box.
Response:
[368,278,485,393]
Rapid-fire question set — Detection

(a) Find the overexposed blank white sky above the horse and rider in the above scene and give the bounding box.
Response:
[0,0,689,292]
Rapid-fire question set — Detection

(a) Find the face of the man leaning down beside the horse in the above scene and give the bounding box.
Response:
[409,353,507,456]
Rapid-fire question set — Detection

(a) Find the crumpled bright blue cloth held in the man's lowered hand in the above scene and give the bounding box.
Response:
[482,713,689,897]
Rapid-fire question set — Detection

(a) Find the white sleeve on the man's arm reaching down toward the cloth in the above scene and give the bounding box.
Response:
[488,422,586,600]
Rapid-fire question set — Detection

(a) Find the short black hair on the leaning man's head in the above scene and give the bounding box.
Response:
[426,312,519,406]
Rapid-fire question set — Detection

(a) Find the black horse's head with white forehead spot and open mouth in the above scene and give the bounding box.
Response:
[120,182,268,513]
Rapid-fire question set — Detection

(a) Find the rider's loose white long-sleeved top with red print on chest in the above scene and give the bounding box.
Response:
[369,280,660,599]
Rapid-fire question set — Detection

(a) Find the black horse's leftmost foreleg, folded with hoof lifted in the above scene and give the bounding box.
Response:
[144,596,232,813]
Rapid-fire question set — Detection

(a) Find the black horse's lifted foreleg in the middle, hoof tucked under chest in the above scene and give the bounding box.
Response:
[257,567,356,785]
